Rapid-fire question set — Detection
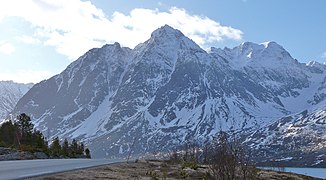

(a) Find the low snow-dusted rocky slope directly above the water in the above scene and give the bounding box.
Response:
[245,109,326,167]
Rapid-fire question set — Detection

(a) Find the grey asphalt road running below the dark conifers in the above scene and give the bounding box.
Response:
[0,159,119,180]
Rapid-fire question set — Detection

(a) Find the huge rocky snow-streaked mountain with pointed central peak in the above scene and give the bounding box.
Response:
[13,25,326,162]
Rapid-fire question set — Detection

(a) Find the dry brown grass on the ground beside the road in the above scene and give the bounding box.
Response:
[31,160,317,180]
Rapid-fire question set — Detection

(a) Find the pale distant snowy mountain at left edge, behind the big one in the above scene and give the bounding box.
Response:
[0,81,33,122]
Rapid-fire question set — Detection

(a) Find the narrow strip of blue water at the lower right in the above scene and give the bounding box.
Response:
[258,167,326,179]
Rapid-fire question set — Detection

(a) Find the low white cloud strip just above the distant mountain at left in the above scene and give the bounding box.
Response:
[0,70,52,83]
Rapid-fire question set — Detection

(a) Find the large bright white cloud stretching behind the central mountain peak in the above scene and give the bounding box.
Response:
[0,0,242,59]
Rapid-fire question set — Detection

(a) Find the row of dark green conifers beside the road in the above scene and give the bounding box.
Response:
[0,113,91,158]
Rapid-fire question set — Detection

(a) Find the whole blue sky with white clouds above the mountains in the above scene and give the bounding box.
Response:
[0,0,326,83]
